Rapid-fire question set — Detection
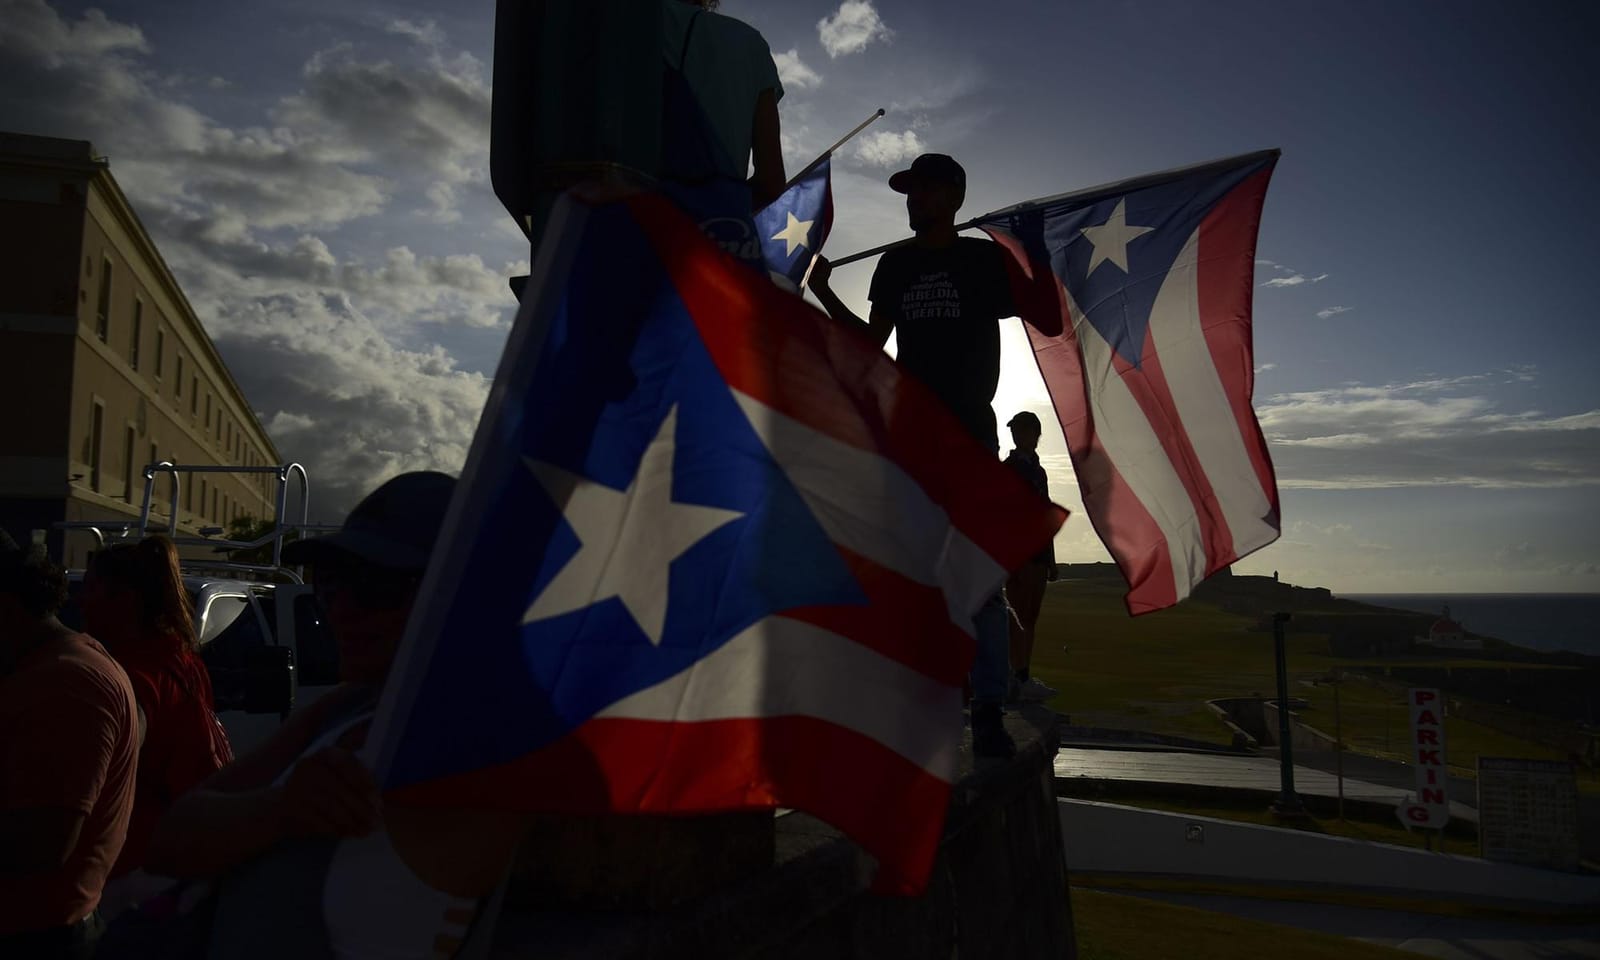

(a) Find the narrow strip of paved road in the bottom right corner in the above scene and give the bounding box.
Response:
[1107,891,1600,960]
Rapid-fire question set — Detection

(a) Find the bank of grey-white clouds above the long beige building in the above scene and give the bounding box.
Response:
[0,0,526,518]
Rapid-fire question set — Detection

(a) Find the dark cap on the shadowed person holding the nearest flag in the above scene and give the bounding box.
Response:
[283,470,456,571]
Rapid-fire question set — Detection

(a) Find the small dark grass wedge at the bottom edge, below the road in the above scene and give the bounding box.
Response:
[1072,886,1416,960]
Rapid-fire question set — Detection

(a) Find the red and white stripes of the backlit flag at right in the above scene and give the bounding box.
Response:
[986,166,1280,614]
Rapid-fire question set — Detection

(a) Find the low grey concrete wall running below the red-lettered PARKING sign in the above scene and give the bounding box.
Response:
[1058,800,1600,912]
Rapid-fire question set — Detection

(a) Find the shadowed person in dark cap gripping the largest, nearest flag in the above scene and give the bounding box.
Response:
[149,472,520,960]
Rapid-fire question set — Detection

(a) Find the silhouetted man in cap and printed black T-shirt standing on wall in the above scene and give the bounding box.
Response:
[811,154,1016,757]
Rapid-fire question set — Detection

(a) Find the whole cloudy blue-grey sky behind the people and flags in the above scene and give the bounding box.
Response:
[0,0,1600,592]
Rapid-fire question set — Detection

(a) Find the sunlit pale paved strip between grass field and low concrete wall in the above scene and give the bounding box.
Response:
[1056,747,1478,822]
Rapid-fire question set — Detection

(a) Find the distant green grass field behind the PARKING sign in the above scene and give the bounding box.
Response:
[1034,581,1600,790]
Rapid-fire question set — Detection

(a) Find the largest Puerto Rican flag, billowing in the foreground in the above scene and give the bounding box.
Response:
[371,197,1066,891]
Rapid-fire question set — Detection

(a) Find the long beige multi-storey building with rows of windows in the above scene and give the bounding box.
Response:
[0,133,280,566]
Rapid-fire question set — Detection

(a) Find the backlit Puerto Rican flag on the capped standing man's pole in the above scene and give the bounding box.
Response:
[973,150,1280,614]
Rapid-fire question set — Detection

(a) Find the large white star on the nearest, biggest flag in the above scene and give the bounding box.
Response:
[522,405,744,646]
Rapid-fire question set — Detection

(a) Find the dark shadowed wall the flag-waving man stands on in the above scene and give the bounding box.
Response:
[493,707,1077,960]
